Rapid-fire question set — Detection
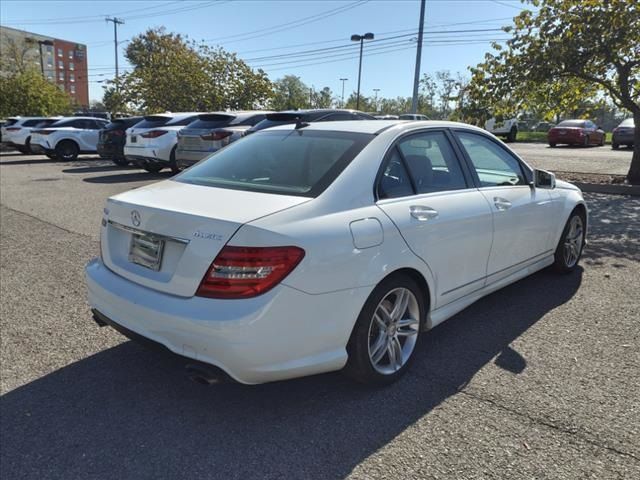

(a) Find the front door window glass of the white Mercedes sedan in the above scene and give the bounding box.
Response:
[456,132,527,187]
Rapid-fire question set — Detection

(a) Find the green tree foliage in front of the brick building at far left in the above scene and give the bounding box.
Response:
[0,69,73,118]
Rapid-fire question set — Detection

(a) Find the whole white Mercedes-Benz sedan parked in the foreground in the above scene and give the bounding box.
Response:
[86,120,587,384]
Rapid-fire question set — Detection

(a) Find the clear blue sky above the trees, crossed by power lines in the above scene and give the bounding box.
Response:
[0,0,523,100]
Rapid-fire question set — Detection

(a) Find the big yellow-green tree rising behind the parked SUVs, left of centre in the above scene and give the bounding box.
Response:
[103,28,272,113]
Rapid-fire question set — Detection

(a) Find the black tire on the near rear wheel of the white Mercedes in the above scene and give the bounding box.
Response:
[344,274,427,385]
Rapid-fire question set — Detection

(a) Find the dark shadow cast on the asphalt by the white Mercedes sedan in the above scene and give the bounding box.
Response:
[0,269,582,479]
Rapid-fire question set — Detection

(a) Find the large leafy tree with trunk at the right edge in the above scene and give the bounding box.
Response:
[474,0,640,184]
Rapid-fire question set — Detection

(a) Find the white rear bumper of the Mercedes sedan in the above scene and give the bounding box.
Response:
[85,259,370,384]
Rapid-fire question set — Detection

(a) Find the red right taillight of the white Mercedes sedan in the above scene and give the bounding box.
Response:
[196,246,304,298]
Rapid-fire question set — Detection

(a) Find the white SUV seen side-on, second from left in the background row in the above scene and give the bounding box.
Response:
[31,117,109,161]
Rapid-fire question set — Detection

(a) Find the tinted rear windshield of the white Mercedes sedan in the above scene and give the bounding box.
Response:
[174,130,374,197]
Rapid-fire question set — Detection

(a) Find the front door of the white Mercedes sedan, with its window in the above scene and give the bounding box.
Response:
[455,130,555,283]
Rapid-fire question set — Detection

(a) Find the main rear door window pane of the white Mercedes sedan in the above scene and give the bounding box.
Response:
[398,132,467,193]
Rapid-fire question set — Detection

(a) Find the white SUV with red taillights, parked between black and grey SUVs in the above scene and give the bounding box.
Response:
[124,112,200,173]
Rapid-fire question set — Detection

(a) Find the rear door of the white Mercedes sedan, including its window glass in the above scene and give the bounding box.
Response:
[376,130,493,308]
